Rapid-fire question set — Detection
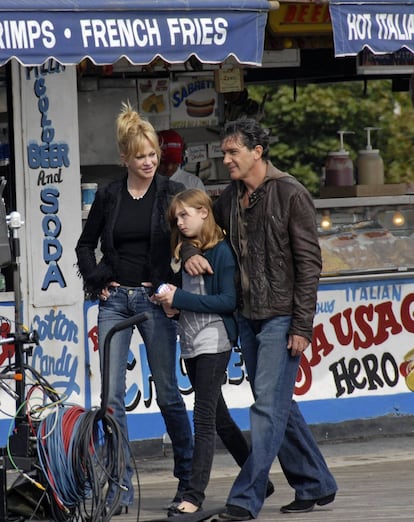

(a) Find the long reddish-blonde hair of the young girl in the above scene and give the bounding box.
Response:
[168,189,224,260]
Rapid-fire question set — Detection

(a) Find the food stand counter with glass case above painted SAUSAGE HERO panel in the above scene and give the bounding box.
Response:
[296,195,414,422]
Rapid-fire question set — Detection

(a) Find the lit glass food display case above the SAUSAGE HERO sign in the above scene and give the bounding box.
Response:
[315,194,414,281]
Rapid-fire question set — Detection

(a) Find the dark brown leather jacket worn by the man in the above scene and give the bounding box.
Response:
[214,162,322,340]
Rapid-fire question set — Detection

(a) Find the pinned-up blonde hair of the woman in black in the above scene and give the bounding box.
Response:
[116,102,161,162]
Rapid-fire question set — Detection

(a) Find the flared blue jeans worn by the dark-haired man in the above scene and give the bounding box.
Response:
[227,316,337,517]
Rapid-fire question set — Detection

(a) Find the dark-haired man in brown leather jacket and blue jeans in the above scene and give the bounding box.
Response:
[184,119,337,522]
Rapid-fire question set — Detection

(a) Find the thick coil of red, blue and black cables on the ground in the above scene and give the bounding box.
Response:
[37,400,125,522]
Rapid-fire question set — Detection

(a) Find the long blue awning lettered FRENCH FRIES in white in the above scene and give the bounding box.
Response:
[0,0,269,65]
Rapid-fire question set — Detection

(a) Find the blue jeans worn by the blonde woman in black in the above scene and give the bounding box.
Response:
[98,287,193,505]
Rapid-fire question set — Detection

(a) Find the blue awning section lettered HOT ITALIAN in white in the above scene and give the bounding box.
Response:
[329,0,414,56]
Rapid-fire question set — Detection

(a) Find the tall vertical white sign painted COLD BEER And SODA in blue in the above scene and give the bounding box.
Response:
[22,60,81,306]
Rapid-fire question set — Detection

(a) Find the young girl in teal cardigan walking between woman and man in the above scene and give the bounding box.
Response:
[155,189,248,516]
